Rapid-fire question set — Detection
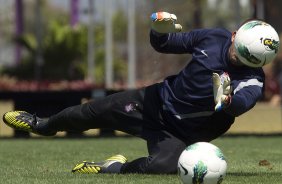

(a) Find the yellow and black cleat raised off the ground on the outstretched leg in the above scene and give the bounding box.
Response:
[3,111,55,135]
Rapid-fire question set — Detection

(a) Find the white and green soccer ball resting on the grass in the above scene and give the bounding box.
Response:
[178,142,227,184]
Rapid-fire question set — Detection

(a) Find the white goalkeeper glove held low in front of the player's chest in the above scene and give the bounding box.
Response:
[212,73,232,111]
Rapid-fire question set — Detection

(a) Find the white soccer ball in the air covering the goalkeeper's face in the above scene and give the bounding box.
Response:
[234,20,279,67]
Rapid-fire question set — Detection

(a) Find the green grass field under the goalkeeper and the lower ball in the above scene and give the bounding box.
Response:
[0,136,282,184]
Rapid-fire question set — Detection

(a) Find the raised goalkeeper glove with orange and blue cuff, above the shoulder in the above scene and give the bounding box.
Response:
[151,12,182,33]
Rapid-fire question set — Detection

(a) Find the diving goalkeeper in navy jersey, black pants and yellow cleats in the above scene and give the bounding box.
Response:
[3,12,278,174]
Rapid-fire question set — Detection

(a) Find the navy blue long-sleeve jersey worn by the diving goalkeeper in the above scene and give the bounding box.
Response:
[150,28,264,119]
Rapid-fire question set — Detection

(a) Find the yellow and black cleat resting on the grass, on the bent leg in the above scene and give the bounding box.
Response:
[72,155,127,174]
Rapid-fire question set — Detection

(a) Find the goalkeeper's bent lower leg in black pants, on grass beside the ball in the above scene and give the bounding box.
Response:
[121,130,186,174]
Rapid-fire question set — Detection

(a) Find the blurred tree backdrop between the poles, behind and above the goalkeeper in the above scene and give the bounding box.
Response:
[0,0,280,92]
